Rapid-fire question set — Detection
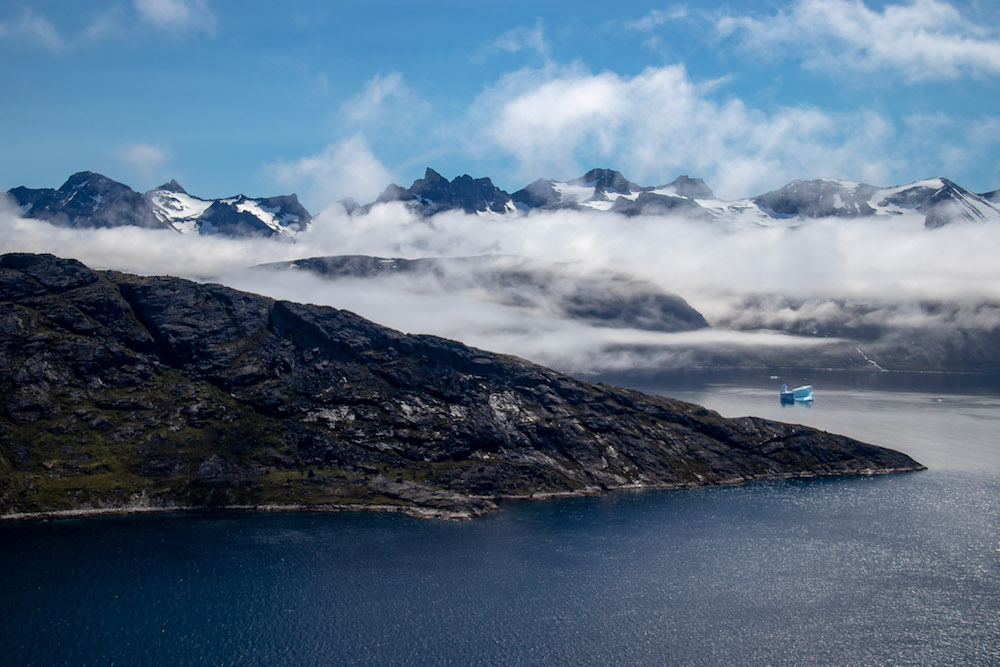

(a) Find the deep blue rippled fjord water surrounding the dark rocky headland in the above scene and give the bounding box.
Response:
[0,374,1000,665]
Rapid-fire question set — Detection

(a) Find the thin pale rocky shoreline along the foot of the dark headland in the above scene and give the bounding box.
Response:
[0,465,927,523]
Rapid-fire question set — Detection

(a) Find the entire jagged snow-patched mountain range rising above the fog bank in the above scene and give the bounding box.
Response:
[7,168,1000,237]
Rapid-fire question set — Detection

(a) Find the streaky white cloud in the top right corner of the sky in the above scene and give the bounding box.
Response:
[716,0,1000,81]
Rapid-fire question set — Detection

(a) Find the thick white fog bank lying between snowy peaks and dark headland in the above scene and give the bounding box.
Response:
[0,198,1000,370]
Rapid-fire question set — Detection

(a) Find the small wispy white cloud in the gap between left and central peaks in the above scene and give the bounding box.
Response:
[266,134,392,207]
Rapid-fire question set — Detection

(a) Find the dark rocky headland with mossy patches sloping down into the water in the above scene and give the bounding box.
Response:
[0,254,921,517]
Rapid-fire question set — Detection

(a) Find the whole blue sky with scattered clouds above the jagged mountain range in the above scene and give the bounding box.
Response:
[0,0,1000,211]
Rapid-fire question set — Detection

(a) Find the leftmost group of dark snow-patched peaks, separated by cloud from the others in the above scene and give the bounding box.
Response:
[7,172,312,236]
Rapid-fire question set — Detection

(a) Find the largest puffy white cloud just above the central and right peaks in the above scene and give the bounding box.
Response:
[472,65,894,199]
